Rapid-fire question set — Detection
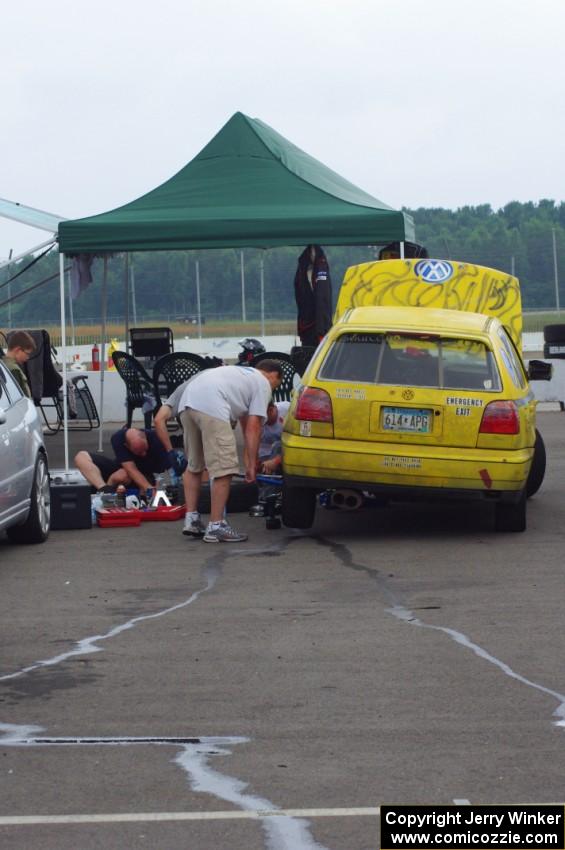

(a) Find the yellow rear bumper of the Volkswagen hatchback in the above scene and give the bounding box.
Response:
[283,433,533,501]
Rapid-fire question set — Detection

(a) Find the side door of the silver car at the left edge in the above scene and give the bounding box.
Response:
[0,363,31,528]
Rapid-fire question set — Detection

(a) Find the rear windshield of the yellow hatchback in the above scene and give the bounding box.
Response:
[319,333,500,392]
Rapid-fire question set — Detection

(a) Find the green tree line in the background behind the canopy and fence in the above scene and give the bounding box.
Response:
[0,200,565,328]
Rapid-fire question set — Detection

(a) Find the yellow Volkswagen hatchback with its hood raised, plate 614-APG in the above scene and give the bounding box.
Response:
[282,260,551,531]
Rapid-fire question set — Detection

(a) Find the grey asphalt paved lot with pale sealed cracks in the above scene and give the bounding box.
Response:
[0,412,565,850]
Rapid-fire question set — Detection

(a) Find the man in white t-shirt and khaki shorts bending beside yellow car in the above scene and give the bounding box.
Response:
[178,360,282,543]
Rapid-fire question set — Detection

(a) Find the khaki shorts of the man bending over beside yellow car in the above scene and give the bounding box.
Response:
[180,407,239,478]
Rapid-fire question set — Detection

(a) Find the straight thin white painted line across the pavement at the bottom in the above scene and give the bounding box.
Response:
[0,806,380,826]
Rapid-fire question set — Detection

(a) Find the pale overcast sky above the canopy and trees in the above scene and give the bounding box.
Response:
[0,0,565,258]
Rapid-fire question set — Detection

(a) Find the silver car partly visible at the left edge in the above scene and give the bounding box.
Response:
[0,359,51,543]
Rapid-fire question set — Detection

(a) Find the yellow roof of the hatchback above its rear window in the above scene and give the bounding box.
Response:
[334,307,498,333]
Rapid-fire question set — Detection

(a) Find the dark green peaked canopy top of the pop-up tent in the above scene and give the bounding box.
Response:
[59,107,414,254]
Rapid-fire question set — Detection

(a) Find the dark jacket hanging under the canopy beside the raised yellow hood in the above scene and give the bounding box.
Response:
[294,245,332,345]
